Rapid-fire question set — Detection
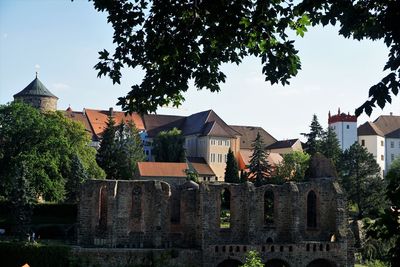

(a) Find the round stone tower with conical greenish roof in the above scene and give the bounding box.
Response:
[14,72,58,112]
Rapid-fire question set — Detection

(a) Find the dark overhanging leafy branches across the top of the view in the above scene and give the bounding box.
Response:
[93,0,400,115]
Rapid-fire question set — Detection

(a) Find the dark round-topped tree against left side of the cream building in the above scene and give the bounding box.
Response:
[152,128,185,162]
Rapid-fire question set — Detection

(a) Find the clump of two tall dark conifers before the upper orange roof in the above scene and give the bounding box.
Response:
[96,116,145,180]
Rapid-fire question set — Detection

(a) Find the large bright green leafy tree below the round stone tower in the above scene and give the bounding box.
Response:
[0,103,104,201]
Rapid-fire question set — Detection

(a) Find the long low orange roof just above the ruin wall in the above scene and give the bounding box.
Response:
[137,162,188,178]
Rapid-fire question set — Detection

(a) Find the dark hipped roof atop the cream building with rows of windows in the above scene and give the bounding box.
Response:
[182,110,240,138]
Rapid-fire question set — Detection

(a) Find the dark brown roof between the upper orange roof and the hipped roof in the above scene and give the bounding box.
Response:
[143,114,185,137]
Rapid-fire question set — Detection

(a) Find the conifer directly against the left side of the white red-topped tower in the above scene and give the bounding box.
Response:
[320,126,342,166]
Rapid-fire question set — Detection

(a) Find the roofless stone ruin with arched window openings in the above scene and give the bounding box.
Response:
[78,178,354,267]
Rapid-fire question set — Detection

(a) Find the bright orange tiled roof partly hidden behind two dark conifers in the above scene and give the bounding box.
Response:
[85,109,144,136]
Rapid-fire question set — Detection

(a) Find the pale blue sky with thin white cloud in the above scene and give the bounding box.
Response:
[0,0,400,139]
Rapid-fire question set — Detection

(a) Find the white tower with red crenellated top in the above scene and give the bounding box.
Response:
[328,108,357,151]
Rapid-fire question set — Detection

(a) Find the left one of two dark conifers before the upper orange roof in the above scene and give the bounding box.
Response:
[96,116,118,179]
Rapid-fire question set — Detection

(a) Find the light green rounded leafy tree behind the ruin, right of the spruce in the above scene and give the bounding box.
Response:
[276,151,310,182]
